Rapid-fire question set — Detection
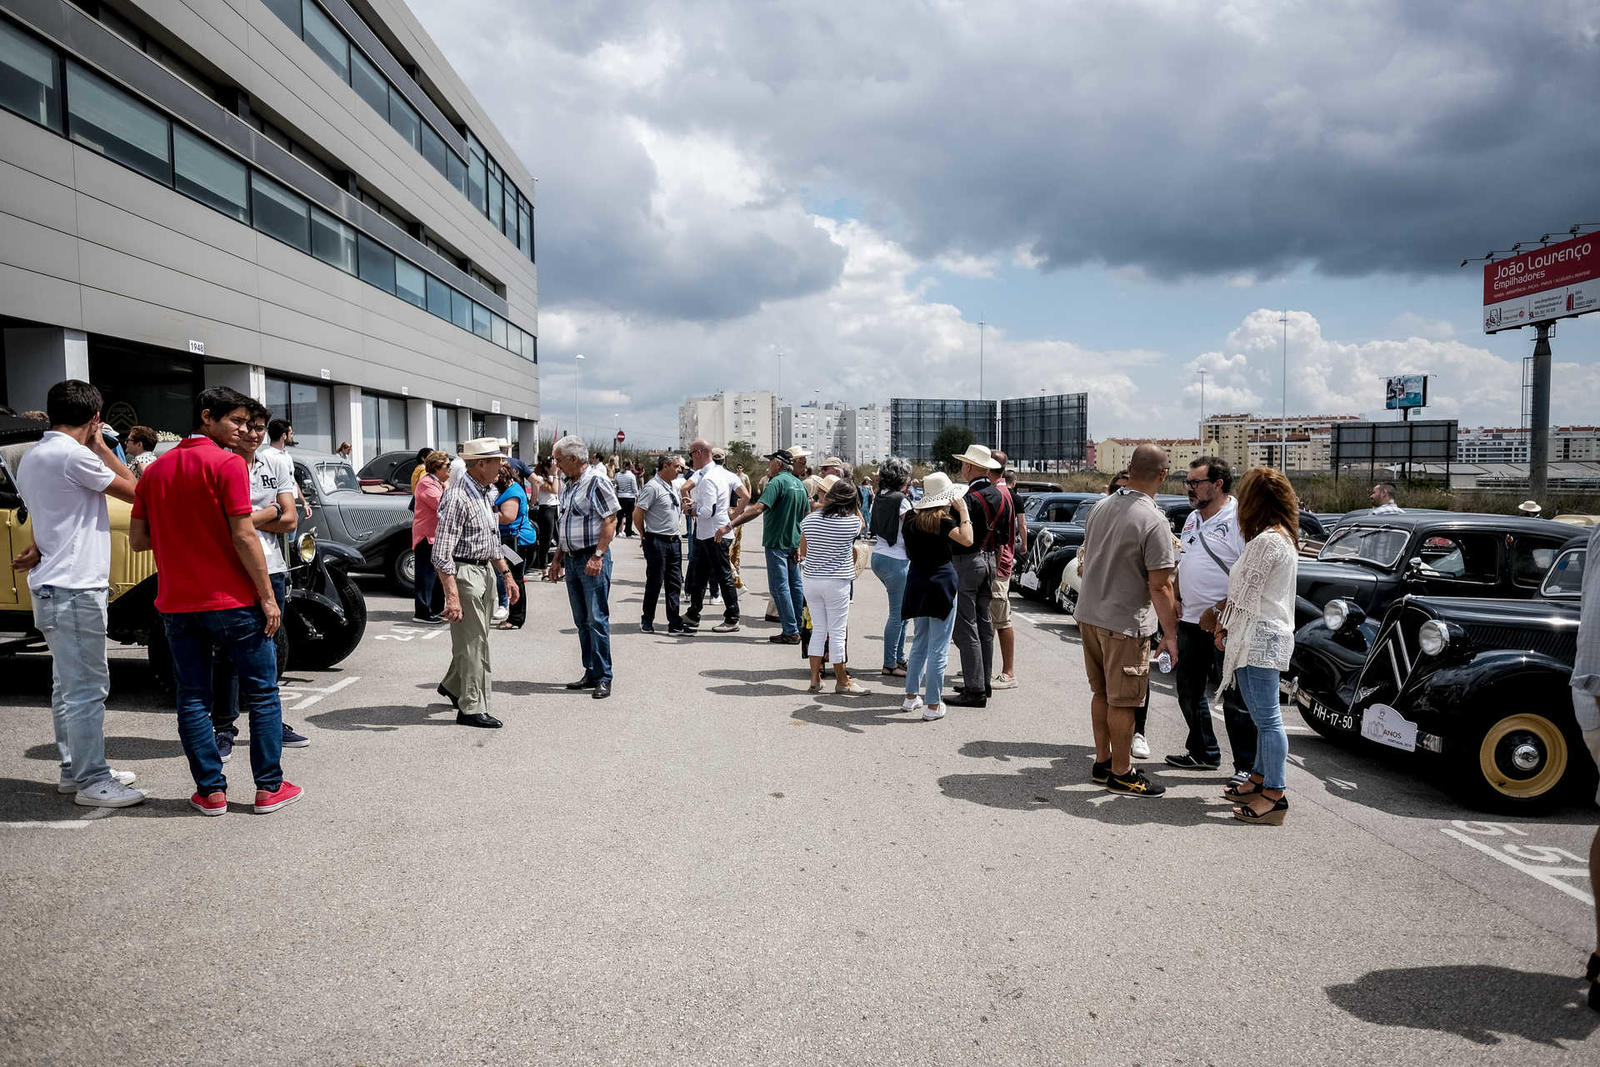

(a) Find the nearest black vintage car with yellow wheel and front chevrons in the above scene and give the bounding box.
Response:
[1283,528,1595,813]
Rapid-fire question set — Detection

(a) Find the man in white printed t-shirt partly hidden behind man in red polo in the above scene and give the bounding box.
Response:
[211,402,310,763]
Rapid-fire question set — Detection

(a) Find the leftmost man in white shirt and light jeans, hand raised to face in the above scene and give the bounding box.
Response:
[11,379,144,808]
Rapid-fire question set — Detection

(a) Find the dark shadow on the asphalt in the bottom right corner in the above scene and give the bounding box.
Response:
[1326,957,1600,1048]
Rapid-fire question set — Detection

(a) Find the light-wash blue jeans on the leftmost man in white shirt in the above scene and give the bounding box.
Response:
[34,585,110,789]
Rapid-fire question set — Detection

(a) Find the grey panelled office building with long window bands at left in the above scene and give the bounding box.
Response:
[0,0,539,464]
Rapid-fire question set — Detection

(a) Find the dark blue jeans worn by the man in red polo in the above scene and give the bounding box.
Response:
[162,605,283,795]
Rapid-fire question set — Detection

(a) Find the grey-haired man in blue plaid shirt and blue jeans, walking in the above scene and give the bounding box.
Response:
[549,435,619,701]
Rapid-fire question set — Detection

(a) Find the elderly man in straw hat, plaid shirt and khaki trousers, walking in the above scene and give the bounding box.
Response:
[434,437,522,729]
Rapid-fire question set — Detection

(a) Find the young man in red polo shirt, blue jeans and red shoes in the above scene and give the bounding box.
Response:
[128,386,301,816]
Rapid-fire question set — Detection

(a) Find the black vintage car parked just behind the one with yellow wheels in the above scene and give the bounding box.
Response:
[1294,510,1573,625]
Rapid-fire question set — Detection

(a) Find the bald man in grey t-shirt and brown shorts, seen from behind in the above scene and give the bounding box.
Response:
[1075,442,1179,797]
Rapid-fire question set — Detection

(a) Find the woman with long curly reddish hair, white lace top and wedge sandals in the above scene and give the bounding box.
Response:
[1216,467,1299,825]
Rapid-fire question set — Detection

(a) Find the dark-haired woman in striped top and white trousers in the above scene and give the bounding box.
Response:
[800,478,870,694]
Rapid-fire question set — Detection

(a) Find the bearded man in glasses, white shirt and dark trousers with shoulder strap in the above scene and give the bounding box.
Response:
[1166,456,1256,777]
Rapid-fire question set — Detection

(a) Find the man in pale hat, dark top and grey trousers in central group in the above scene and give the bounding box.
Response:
[946,445,1016,707]
